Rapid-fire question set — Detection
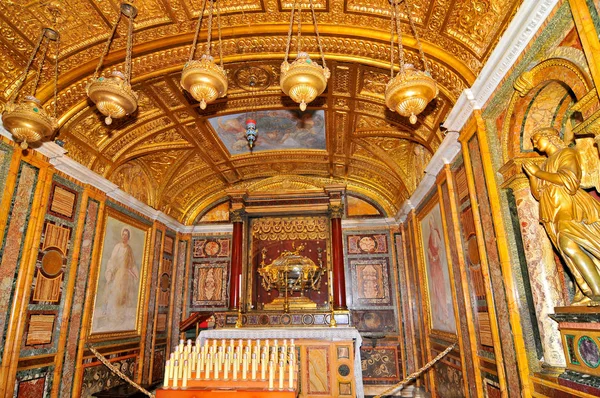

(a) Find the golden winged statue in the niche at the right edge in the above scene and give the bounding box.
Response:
[523,128,600,305]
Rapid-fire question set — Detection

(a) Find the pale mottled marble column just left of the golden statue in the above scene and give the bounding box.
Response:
[506,174,566,368]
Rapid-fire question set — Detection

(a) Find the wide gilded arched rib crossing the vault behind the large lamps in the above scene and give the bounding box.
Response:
[31,24,475,107]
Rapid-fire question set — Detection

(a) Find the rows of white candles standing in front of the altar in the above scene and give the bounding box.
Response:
[163,339,296,390]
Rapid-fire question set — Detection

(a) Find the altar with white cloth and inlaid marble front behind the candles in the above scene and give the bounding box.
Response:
[198,327,364,398]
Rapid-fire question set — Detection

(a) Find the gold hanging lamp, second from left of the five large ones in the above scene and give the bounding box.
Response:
[87,1,138,125]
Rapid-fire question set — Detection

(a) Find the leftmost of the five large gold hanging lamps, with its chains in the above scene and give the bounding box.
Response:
[2,4,60,149]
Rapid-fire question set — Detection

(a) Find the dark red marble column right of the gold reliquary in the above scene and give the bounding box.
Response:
[329,205,348,310]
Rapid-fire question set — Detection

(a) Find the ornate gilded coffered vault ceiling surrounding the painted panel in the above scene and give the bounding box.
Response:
[0,0,520,223]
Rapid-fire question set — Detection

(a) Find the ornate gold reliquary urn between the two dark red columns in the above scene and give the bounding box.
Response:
[258,244,325,312]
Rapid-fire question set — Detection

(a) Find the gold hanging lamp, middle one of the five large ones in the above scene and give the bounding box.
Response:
[181,0,228,109]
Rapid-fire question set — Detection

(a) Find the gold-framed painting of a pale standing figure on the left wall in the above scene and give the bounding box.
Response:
[89,206,152,341]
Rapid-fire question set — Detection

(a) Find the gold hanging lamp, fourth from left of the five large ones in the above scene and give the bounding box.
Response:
[280,0,331,111]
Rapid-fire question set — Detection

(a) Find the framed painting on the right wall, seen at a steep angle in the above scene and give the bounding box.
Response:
[419,196,456,336]
